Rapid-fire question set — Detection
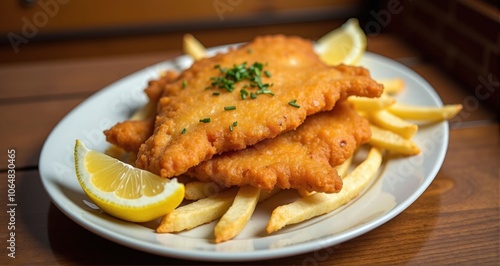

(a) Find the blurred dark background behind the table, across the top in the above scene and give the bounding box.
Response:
[0,0,500,110]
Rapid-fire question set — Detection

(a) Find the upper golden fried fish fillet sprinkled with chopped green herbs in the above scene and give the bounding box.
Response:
[136,35,383,178]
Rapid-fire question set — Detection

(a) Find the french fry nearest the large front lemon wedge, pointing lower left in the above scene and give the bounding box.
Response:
[156,188,238,233]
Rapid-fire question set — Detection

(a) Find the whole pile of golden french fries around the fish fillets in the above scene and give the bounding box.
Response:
[138,34,462,243]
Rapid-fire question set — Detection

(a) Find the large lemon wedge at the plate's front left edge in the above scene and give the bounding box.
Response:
[75,140,184,222]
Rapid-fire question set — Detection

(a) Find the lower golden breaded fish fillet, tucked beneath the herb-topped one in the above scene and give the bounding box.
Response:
[186,101,370,193]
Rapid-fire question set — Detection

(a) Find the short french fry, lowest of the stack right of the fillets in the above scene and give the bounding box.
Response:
[369,125,420,155]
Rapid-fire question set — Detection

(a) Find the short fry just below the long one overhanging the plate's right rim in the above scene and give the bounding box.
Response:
[369,110,418,139]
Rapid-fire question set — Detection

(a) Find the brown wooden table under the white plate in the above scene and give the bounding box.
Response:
[0,34,500,265]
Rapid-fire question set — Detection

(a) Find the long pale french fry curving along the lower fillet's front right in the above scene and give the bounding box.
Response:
[266,148,382,233]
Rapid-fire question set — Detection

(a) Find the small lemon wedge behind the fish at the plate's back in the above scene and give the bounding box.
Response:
[316,18,366,65]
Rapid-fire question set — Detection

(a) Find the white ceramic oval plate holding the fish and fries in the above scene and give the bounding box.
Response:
[39,44,448,261]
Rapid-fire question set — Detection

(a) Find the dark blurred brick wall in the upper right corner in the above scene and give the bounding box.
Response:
[388,0,500,112]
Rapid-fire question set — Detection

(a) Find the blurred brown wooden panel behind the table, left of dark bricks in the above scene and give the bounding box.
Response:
[0,0,371,62]
